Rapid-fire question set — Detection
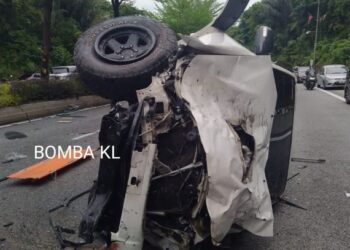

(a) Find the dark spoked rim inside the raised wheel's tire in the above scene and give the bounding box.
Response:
[95,25,156,64]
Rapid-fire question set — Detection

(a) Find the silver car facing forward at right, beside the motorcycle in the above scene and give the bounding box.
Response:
[317,64,349,89]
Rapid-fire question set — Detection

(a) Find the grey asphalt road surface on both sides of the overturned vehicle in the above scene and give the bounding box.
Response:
[0,84,350,250]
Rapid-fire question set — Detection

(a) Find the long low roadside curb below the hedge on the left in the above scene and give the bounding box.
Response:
[0,96,110,125]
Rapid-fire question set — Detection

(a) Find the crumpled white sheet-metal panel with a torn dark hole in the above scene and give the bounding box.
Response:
[176,55,277,242]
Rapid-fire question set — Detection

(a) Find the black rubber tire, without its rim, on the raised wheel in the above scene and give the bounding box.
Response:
[74,16,177,101]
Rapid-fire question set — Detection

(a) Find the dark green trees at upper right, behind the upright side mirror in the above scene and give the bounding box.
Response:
[231,0,350,66]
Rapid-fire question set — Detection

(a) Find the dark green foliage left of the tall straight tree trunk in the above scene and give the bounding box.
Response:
[0,0,42,79]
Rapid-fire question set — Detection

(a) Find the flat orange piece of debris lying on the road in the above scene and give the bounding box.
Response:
[0,150,89,182]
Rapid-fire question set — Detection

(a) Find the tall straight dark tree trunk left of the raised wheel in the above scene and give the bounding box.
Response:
[41,0,53,81]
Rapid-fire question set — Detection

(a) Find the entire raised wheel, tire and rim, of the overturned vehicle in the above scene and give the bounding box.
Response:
[74,16,177,101]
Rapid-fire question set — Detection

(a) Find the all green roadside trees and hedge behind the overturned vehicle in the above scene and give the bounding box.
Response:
[0,0,350,107]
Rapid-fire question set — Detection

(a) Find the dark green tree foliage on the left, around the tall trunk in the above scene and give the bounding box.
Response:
[0,0,143,80]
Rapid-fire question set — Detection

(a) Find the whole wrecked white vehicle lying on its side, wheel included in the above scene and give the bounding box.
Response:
[70,0,295,250]
